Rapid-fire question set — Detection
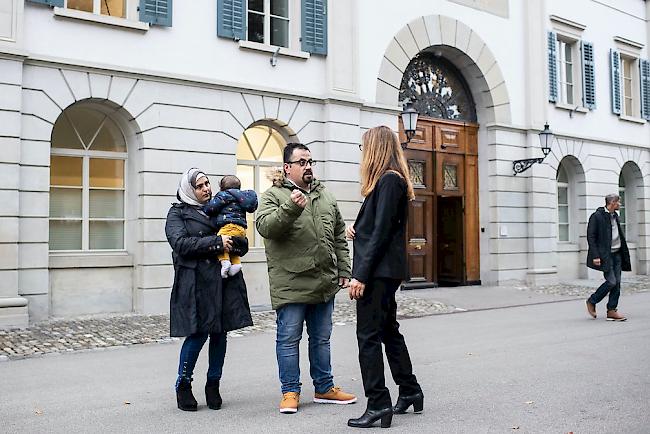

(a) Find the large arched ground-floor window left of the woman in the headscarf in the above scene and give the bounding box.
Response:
[49,103,126,251]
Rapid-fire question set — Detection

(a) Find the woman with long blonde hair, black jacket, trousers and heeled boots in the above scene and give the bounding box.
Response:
[347,126,424,428]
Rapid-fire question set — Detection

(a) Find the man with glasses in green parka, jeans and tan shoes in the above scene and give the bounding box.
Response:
[256,143,357,413]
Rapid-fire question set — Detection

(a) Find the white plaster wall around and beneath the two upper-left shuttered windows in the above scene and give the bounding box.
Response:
[24,0,336,95]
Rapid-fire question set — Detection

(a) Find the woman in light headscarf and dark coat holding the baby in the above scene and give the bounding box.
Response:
[165,168,253,411]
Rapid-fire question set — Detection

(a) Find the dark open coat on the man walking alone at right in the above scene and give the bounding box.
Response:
[587,206,632,272]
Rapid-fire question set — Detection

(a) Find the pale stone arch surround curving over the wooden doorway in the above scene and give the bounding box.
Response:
[376,15,511,124]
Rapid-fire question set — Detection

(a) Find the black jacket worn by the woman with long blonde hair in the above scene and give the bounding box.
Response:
[352,172,408,283]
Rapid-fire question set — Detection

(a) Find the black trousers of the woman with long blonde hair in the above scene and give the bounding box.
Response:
[357,279,422,410]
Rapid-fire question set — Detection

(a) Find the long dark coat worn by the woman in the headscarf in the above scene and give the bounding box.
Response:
[165,203,253,336]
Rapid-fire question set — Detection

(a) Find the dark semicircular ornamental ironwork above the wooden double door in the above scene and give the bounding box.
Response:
[399,51,476,122]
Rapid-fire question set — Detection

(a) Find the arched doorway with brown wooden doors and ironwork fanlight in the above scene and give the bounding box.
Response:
[399,50,480,287]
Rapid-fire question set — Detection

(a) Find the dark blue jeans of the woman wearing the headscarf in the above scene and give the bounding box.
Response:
[176,332,226,388]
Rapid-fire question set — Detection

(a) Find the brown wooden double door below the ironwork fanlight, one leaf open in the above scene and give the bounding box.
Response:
[400,118,480,287]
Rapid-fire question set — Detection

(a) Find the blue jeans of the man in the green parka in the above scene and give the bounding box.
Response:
[275,298,334,393]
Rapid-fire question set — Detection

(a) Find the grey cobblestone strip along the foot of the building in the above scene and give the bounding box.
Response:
[0,276,650,361]
